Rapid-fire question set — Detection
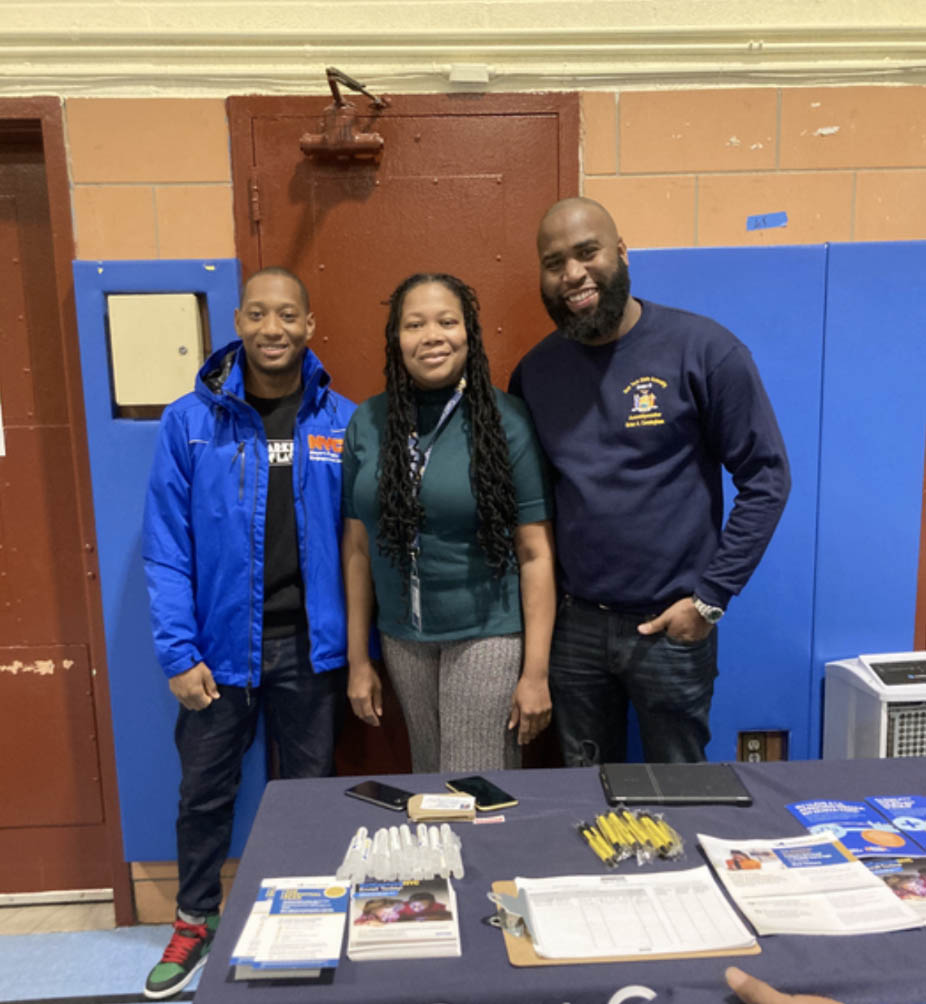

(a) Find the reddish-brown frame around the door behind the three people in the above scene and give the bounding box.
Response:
[225,91,581,275]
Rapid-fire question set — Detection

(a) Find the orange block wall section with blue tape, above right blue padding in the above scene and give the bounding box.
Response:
[583,85,926,247]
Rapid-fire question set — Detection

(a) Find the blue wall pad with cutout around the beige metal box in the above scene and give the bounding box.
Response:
[73,260,264,860]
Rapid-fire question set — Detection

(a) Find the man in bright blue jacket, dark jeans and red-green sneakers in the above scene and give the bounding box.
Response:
[144,268,354,999]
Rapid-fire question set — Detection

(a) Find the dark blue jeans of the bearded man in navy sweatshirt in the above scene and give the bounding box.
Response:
[549,595,717,767]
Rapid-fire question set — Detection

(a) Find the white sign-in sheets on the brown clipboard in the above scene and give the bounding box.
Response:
[515,865,755,959]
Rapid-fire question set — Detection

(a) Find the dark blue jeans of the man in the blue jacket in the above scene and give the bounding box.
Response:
[174,635,346,914]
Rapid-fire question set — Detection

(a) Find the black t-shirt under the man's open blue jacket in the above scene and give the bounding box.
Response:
[245,388,307,638]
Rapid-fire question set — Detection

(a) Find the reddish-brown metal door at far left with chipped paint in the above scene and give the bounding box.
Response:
[0,122,113,892]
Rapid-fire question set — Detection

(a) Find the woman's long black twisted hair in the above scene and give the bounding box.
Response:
[377,272,517,577]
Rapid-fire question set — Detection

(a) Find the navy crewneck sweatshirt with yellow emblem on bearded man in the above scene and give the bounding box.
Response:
[509,300,790,612]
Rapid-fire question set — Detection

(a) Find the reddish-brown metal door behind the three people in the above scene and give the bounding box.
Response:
[228,94,578,773]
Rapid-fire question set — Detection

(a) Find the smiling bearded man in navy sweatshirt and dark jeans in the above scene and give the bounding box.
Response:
[509,198,790,765]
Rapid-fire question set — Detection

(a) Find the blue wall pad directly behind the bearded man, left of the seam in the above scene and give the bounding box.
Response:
[631,246,827,760]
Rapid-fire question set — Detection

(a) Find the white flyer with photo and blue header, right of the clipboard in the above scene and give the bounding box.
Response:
[698,833,923,935]
